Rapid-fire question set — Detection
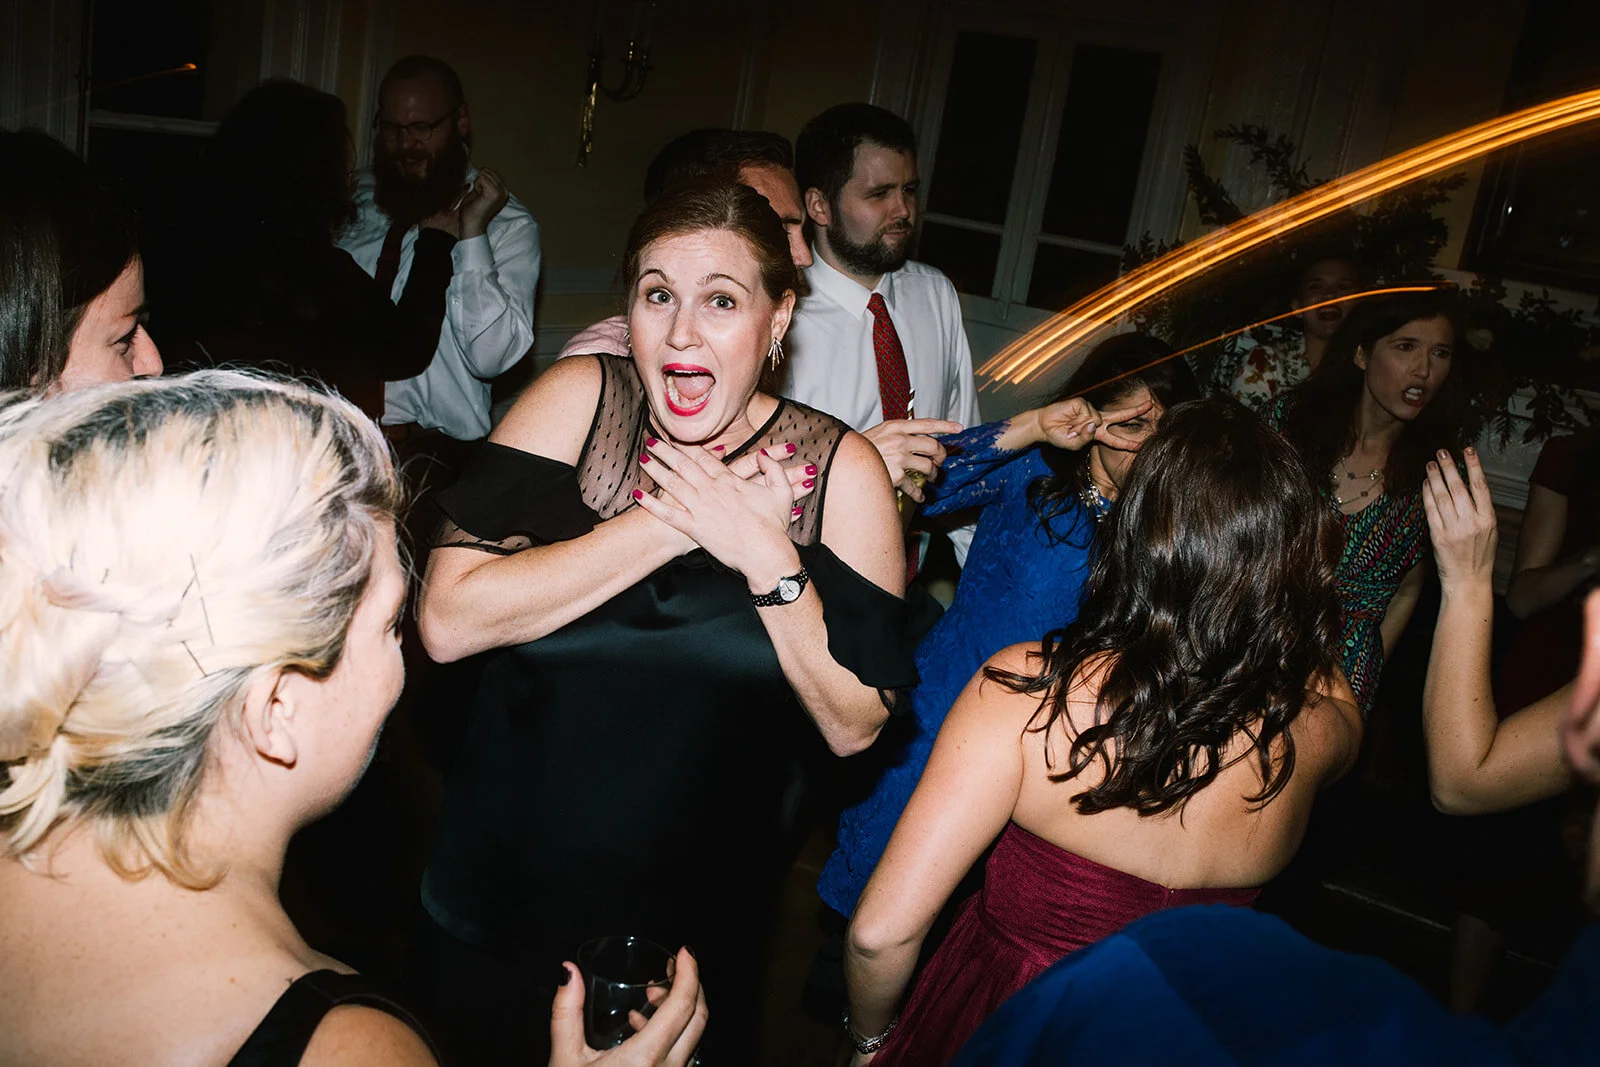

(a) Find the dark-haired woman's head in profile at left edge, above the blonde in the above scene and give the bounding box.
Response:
[0,130,162,390]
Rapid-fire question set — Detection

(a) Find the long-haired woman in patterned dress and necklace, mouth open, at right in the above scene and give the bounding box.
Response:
[1267,290,1467,713]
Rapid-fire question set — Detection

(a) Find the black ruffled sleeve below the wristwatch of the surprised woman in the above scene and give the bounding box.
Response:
[795,542,939,713]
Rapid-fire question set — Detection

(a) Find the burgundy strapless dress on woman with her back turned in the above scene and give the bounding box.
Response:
[872,822,1259,1067]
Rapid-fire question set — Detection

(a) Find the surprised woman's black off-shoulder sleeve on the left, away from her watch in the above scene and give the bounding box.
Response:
[434,442,598,544]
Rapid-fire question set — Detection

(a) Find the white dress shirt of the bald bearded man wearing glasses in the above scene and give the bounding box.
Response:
[339,170,539,442]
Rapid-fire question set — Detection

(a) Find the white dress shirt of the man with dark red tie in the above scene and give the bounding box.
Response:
[782,250,981,563]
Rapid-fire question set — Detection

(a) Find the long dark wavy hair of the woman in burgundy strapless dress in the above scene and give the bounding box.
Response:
[986,398,1339,814]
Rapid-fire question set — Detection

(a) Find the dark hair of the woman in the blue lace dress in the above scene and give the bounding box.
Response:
[1027,333,1200,539]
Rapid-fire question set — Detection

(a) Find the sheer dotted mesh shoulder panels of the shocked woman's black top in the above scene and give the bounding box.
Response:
[578,355,850,544]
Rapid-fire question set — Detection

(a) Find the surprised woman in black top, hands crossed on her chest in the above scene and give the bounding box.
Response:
[419,184,915,1064]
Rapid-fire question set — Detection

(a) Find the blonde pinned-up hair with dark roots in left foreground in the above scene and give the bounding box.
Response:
[0,371,400,885]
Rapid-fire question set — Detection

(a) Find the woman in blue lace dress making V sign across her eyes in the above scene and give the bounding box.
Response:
[818,333,1200,917]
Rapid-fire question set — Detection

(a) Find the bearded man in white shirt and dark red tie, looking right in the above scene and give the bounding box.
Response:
[784,104,979,560]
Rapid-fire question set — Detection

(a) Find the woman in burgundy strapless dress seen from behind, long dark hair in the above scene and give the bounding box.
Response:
[845,400,1362,1067]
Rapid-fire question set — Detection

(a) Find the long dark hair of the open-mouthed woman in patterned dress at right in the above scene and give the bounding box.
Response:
[1283,290,1470,496]
